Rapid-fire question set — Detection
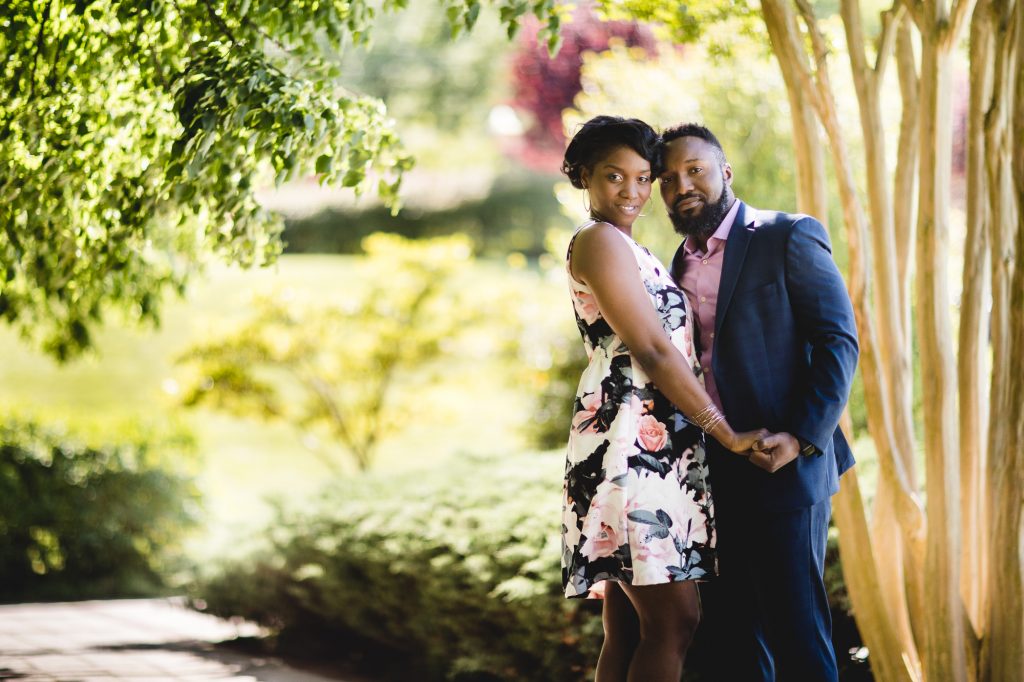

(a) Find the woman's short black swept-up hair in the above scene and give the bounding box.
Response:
[562,116,662,189]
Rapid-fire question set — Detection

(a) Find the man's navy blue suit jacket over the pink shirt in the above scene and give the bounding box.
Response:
[672,202,858,511]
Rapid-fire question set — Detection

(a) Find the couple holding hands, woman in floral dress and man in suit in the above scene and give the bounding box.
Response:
[562,116,858,682]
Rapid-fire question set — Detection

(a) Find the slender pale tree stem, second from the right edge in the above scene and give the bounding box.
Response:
[956,0,995,632]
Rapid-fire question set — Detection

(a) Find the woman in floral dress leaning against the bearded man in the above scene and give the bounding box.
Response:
[562,116,768,682]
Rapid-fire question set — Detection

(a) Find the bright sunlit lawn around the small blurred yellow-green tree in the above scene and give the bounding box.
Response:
[0,251,557,557]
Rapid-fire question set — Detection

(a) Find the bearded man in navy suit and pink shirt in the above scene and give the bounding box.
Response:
[659,124,858,682]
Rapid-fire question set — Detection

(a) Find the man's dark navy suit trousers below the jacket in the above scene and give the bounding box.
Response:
[695,499,839,682]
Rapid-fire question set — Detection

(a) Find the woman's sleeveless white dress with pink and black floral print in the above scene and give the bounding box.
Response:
[562,223,716,597]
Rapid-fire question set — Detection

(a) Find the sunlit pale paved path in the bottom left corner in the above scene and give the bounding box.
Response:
[0,599,356,682]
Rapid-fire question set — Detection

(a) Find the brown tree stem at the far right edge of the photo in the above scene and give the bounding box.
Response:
[981,0,1024,682]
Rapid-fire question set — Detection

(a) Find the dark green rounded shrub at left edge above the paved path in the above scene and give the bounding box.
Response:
[0,420,198,601]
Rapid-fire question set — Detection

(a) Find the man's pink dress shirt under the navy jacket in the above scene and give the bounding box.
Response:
[679,200,739,410]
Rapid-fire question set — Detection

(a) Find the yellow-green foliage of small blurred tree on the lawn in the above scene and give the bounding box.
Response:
[182,233,484,474]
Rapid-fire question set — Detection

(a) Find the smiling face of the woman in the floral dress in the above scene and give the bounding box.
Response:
[581,146,651,227]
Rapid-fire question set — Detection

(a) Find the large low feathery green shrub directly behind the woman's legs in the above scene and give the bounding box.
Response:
[196,453,859,682]
